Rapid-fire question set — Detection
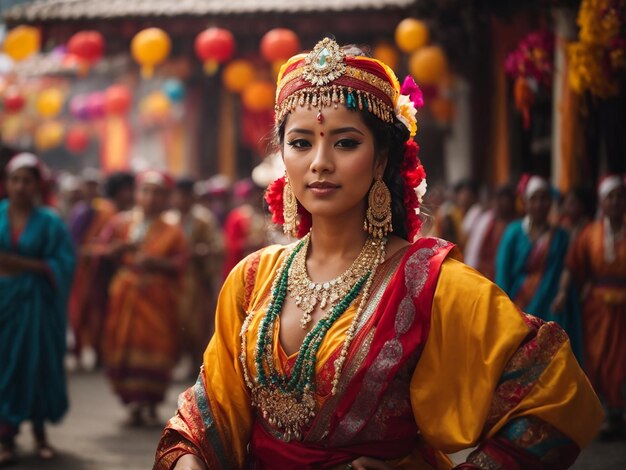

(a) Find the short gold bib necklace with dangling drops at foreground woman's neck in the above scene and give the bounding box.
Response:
[287,233,378,330]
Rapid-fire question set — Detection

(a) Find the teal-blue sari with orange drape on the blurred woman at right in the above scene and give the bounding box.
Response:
[495,220,582,363]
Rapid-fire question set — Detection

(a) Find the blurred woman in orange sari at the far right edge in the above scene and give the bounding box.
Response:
[565,175,626,440]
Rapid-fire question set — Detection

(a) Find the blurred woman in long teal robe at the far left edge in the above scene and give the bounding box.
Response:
[0,153,74,464]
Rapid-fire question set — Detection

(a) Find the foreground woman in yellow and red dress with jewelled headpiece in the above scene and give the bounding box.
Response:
[155,38,601,469]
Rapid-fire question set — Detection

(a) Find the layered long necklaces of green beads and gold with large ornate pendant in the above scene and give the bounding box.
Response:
[240,235,386,441]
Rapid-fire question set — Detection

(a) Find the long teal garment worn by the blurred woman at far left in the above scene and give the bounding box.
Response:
[0,199,74,426]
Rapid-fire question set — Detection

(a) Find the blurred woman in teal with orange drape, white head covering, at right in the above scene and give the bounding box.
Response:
[496,176,582,361]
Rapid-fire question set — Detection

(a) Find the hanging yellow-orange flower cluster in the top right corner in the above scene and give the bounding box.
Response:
[568,0,626,98]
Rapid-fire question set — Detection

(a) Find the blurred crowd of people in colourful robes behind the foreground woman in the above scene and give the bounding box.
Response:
[0,154,626,462]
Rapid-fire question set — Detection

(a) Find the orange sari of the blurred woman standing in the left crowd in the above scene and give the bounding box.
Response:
[103,211,186,403]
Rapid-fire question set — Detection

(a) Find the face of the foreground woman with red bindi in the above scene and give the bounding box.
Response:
[282,106,384,224]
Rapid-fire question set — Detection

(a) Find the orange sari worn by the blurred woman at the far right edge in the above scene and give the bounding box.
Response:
[566,220,626,408]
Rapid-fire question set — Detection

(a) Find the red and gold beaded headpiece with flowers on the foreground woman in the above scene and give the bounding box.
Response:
[266,38,426,238]
